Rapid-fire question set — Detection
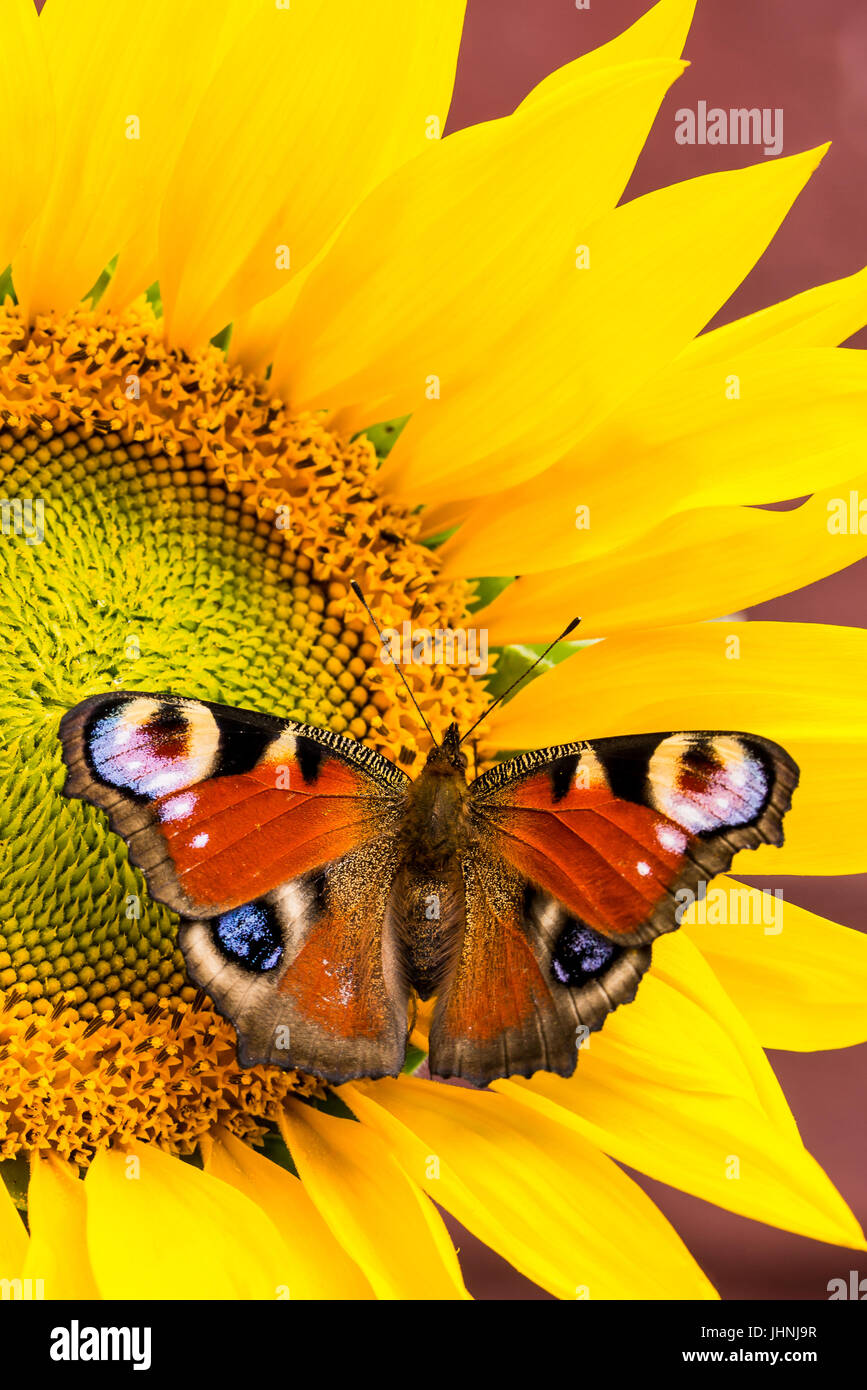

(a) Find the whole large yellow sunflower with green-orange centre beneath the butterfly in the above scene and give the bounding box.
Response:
[0,0,867,1298]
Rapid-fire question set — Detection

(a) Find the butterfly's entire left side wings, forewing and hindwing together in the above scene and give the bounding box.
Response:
[60,692,408,1081]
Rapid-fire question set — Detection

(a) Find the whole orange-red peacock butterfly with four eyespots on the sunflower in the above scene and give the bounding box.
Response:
[60,597,799,1086]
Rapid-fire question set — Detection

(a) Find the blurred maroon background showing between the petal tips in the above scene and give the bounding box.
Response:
[449,0,867,1300]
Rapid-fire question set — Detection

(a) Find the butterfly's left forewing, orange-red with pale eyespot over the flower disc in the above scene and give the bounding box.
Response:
[60,692,407,917]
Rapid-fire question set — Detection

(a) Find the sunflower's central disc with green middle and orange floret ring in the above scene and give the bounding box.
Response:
[0,303,485,1158]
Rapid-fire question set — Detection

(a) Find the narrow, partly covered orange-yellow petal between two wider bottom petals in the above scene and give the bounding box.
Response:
[204,1133,374,1300]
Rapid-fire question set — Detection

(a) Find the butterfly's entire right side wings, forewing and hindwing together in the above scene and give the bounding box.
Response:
[431,733,798,1084]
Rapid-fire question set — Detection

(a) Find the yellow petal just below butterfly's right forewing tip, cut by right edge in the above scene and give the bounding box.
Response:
[684,878,867,1052]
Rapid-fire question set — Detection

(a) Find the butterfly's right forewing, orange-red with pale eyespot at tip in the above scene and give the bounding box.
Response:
[471,734,798,940]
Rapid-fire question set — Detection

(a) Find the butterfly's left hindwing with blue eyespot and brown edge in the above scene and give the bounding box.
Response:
[181,838,408,1083]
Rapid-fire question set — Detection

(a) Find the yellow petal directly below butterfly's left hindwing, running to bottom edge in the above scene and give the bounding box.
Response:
[279,1104,470,1300]
